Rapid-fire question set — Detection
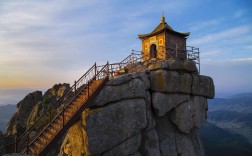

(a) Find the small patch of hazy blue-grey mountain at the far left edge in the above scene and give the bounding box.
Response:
[0,104,17,132]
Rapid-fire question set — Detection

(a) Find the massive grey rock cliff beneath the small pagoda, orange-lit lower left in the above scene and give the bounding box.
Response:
[60,60,214,156]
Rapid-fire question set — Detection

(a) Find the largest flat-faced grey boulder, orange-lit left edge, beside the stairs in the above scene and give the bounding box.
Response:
[82,99,147,155]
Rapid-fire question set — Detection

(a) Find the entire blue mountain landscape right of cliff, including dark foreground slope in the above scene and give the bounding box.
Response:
[201,93,252,156]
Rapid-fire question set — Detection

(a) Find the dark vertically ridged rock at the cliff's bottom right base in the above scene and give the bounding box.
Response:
[156,116,205,156]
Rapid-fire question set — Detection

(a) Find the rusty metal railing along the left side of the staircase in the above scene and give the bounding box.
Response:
[0,64,108,154]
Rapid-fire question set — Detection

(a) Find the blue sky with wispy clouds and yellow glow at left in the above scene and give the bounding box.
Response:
[0,0,252,105]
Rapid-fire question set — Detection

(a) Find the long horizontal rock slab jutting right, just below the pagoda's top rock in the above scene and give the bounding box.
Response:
[150,70,215,98]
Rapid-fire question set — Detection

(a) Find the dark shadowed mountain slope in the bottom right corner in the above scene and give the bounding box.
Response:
[200,123,252,156]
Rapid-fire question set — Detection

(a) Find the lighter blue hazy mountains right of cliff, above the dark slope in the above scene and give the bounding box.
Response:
[208,93,252,143]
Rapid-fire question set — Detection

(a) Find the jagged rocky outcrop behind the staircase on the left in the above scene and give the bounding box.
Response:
[6,84,70,136]
